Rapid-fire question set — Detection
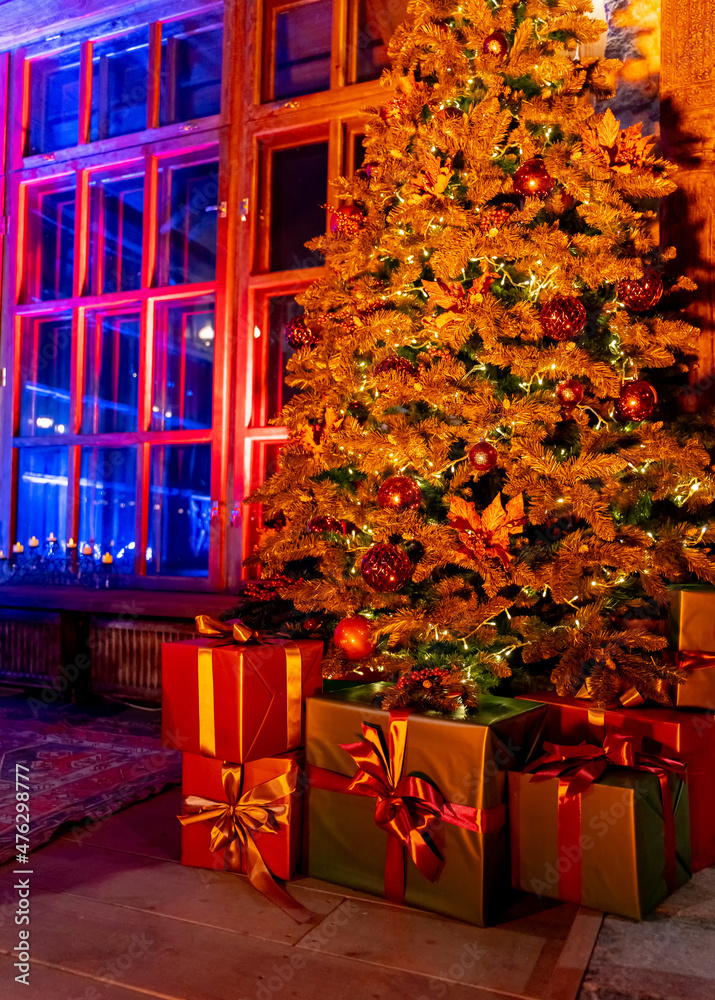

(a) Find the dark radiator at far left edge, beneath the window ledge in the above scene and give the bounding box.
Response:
[0,609,62,685]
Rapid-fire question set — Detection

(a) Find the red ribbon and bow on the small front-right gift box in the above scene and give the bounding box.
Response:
[525,727,685,901]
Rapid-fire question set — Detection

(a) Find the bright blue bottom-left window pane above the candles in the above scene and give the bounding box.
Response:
[17,448,68,546]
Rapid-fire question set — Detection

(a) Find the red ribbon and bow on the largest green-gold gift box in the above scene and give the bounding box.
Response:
[307,710,505,902]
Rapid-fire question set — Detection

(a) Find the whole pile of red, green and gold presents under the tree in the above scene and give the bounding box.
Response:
[158,588,715,926]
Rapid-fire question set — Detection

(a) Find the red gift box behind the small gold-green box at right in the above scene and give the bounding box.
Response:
[525,692,715,871]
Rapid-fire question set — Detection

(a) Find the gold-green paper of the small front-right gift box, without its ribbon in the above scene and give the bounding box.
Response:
[509,768,690,920]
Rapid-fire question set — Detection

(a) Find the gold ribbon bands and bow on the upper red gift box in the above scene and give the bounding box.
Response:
[196,615,303,757]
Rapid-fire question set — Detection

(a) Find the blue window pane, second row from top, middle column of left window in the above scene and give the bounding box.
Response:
[89,168,144,295]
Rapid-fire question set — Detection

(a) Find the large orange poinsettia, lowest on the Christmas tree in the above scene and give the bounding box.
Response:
[447,493,527,569]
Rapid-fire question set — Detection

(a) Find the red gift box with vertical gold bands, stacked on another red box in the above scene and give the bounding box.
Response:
[161,622,323,763]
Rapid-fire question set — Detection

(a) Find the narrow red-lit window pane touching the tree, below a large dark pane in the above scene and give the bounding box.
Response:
[254,295,303,426]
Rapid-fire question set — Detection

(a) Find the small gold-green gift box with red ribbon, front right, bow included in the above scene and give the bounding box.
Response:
[509,730,690,920]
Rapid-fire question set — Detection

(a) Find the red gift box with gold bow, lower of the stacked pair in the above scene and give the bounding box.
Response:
[179,751,305,919]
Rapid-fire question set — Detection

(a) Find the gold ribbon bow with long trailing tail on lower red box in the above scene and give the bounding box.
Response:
[179,764,312,923]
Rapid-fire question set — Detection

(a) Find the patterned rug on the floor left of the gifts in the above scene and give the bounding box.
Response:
[0,695,181,863]
